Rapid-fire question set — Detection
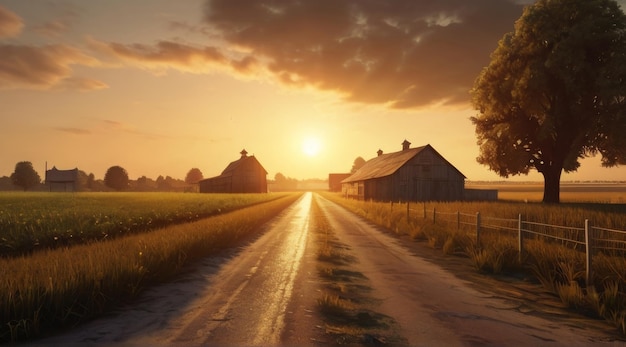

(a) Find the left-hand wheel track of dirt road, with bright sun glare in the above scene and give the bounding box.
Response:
[37,193,322,346]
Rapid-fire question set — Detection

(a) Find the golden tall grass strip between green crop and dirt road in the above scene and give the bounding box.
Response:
[0,194,300,342]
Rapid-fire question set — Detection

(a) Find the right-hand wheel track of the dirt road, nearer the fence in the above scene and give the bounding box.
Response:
[318,194,623,346]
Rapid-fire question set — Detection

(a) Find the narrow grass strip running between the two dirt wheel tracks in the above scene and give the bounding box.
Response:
[311,198,406,345]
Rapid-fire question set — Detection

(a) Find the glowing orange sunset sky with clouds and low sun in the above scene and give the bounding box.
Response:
[0,0,626,181]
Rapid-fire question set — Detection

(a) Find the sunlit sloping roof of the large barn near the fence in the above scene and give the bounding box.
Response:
[341,145,465,183]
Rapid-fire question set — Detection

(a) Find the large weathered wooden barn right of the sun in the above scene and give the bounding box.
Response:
[341,140,465,201]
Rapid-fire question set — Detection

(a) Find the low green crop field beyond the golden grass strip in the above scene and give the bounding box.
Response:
[0,192,283,257]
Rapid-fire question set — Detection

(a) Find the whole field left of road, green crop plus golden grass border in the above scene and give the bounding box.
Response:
[0,193,300,343]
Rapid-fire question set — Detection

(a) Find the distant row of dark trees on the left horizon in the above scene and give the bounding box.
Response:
[0,161,204,192]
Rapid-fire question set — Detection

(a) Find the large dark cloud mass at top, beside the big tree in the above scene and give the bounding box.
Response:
[204,0,522,108]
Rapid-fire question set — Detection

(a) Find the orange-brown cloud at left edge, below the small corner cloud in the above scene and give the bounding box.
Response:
[0,44,106,90]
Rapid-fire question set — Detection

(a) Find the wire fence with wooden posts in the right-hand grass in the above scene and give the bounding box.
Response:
[392,203,626,283]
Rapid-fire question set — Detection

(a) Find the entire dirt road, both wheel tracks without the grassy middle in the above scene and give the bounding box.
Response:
[37,193,623,346]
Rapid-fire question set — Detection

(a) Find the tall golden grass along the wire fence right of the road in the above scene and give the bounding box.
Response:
[322,193,626,335]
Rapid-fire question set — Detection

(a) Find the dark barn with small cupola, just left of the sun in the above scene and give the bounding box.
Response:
[198,149,267,193]
